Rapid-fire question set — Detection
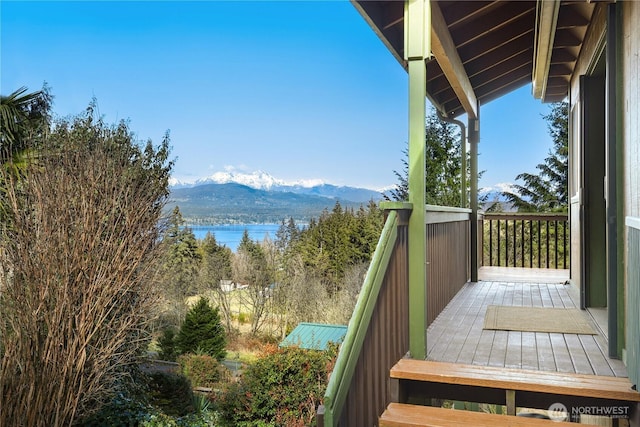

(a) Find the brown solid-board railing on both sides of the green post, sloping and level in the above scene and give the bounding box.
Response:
[317,204,470,427]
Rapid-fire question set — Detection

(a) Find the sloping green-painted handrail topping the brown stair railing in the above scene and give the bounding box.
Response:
[323,211,398,427]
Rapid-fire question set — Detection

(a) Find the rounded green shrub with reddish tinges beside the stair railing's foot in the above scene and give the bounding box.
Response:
[220,347,335,427]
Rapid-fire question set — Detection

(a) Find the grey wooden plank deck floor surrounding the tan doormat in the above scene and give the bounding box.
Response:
[427,270,627,377]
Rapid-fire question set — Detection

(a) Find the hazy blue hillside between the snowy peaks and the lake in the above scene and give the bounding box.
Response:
[167,182,381,224]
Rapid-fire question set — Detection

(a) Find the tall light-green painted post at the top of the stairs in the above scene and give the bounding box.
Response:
[404,0,431,359]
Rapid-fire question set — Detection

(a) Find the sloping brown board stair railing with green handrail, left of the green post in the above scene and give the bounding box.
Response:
[316,211,409,427]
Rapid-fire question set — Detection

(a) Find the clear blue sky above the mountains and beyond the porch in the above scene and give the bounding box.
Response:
[0,0,551,189]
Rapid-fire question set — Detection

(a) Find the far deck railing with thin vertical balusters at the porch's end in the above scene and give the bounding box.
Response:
[478,213,571,269]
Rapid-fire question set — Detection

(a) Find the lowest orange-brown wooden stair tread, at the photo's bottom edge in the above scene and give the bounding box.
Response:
[379,403,575,427]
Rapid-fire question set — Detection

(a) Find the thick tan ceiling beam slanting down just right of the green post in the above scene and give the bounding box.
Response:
[431,2,478,119]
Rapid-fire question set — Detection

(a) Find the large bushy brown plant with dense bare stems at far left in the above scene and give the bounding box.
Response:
[0,133,166,426]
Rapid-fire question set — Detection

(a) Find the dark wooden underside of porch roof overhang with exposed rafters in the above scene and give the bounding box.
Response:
[352,0,598,117]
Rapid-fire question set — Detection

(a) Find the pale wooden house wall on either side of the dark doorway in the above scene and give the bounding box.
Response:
[569,1,640,383]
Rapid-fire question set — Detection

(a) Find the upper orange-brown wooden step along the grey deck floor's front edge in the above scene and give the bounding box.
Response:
[390,359,640,402]
